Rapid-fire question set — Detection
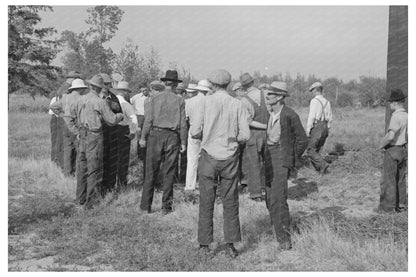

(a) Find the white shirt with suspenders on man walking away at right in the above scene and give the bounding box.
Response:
[306,95,332,135]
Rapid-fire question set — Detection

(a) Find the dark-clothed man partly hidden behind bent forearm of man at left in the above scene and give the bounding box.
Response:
[99,73,122,196]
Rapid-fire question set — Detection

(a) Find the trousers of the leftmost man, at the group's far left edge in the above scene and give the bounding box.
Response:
[50,115,65,169]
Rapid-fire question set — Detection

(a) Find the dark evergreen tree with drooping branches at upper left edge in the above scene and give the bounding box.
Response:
[8,6,59,96]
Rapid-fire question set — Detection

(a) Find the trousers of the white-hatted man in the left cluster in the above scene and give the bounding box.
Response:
[63,124,78,176]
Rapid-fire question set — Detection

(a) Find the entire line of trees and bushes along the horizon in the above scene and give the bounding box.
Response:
[8,6,386,107]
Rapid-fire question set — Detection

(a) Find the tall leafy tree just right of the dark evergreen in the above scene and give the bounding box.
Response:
[61,6,124,76]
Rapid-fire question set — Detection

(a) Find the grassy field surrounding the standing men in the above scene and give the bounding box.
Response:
[8,95,408,271]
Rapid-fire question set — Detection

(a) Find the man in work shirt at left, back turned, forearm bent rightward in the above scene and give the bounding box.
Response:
[76,75,123,209]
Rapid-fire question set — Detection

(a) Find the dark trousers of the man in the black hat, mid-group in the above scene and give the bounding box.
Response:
[140,129,179,211]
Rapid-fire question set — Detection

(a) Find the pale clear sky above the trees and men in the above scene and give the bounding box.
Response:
[37,6,389,81]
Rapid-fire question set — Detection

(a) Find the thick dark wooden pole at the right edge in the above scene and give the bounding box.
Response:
[385,6,408,131]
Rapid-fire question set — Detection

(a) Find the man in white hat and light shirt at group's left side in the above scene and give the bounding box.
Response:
[50,79,88,176]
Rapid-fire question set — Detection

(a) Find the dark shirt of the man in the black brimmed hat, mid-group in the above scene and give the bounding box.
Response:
[142,89,188,145]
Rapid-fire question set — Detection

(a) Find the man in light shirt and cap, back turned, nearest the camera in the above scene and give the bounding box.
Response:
[190,69,250,257]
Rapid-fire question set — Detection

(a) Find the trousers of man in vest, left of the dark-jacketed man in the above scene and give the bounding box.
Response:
[243,129,267,198]
